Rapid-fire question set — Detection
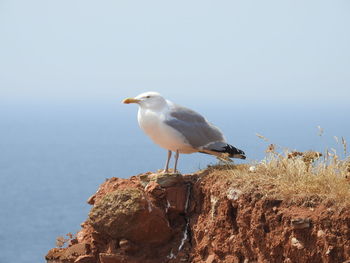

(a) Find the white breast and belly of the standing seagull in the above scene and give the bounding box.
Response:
[137,108,196,153]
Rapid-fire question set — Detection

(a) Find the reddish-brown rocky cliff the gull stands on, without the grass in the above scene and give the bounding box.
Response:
[46,165,350,263]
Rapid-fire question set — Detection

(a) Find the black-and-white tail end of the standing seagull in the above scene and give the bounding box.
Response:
[200,142,246,159]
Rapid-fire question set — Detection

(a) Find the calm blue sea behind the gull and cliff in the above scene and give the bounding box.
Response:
[0,103,350,263]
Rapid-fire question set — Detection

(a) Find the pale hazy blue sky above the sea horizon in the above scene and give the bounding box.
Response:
[0,0,350,104]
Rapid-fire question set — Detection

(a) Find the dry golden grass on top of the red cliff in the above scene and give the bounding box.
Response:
[213,132,350,207]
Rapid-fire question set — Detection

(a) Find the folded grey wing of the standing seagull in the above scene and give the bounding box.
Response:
[165,104,225,148]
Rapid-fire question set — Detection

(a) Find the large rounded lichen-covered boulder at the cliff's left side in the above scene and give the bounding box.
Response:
[89,187,171,243]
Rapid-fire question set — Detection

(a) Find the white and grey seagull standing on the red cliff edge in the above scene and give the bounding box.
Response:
[122,91,246,173]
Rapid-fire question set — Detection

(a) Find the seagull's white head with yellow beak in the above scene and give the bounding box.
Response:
[123,91,167,109]
